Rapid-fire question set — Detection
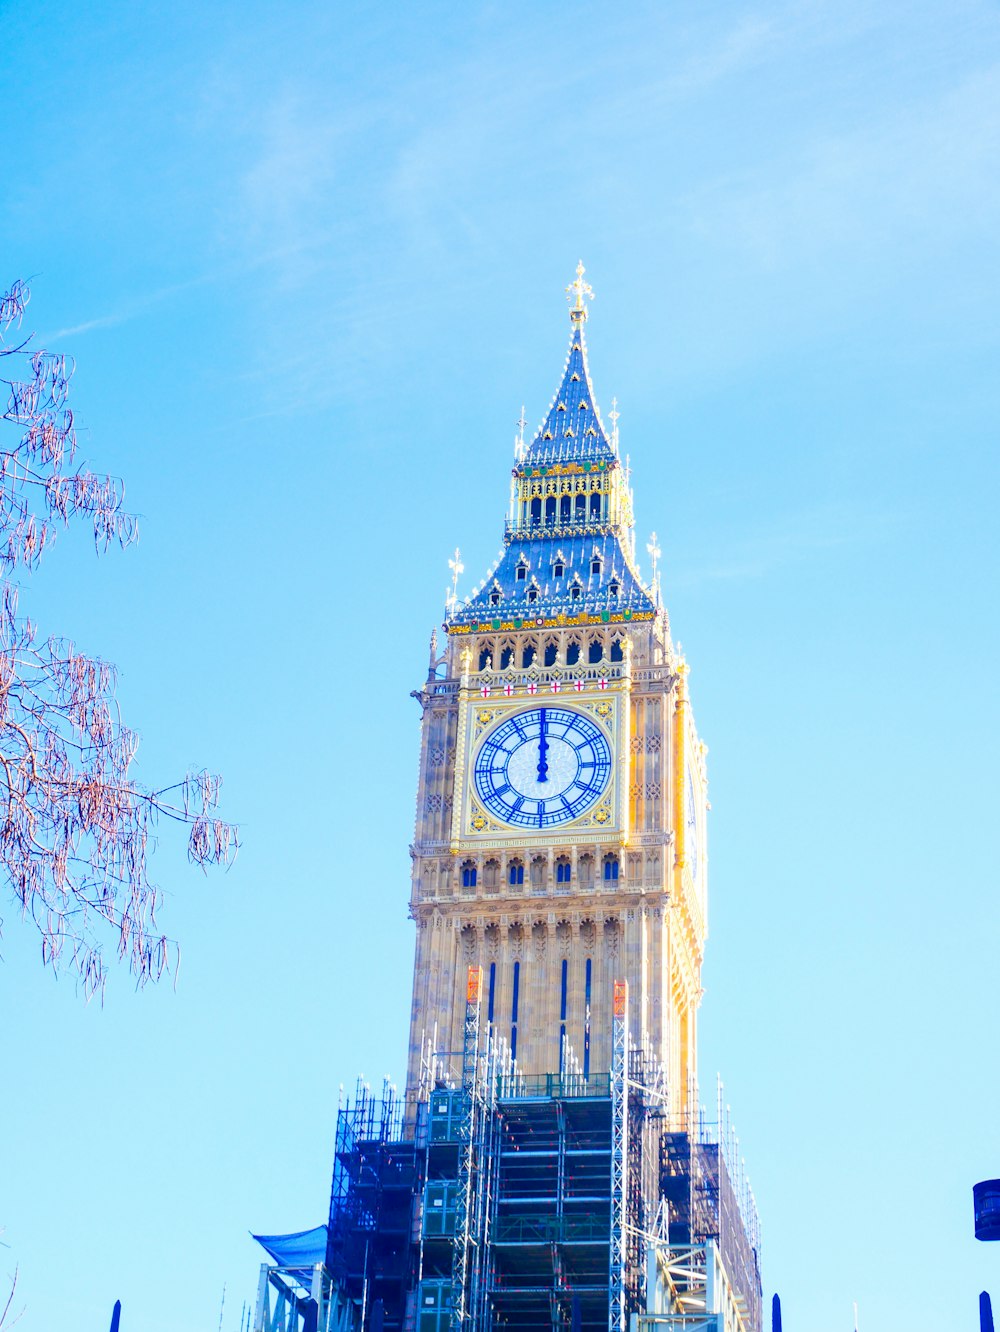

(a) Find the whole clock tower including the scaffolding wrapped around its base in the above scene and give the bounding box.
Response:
[254,265,762,1332]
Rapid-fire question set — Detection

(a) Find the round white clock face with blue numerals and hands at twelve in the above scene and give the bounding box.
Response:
[473,707,611,829]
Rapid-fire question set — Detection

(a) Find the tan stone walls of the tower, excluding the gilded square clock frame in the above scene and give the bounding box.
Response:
[407,615,704,1124]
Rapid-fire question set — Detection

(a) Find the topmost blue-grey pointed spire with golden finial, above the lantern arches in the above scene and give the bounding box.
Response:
[517,262,618,472]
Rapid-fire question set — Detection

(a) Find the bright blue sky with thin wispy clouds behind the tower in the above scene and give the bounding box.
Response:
[0,0,1000,1332]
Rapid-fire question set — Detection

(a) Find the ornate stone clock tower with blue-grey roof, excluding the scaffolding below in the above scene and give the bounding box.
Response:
[407,265,707,1114]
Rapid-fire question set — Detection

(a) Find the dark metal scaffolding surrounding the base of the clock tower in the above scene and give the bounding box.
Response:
[258,967,762,1332]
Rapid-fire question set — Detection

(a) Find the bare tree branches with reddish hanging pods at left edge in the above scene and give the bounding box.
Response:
[0,282,238,998]
